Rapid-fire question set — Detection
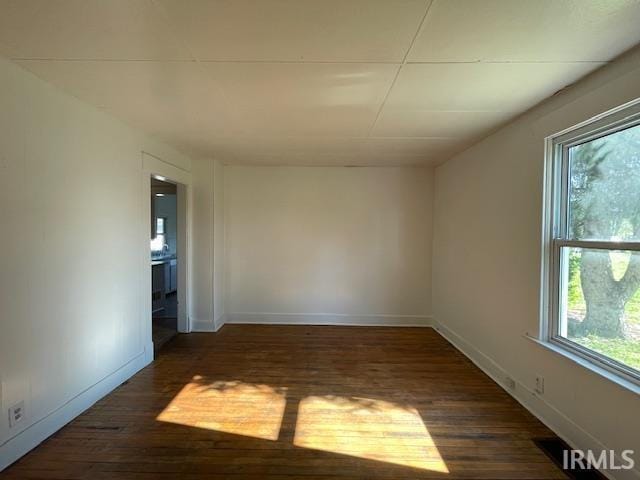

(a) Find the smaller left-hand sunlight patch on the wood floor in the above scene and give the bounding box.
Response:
[157,375,286,441]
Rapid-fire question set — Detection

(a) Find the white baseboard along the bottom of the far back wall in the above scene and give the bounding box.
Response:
[225,313,432,327]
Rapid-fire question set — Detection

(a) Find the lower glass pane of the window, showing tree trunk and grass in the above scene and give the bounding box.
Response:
[558,247,640,370]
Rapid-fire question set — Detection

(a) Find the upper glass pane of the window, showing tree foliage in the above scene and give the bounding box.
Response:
[569,125,640,241]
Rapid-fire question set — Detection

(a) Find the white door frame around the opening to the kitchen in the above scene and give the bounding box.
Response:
[140,151,193,358]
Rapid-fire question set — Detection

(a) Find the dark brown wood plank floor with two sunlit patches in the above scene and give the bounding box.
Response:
[0,325,566,480]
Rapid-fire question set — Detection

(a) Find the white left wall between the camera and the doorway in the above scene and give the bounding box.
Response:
[0,59,190,469]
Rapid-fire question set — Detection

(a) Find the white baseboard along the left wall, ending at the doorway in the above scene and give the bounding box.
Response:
[0,350,153,471]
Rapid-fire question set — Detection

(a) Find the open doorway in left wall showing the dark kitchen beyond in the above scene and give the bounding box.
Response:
[149,176,182,353]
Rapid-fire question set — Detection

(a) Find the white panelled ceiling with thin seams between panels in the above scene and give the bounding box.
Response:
[0,0,640,165]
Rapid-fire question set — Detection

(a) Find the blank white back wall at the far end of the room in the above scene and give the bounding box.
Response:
[224,166,432,323]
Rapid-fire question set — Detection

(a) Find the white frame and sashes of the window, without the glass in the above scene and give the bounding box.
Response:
[540,99,640,385]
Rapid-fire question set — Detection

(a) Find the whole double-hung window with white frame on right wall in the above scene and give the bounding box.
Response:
[543,103,640,383]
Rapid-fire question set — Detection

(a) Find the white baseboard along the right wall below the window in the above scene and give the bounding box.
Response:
[433,320,640,480]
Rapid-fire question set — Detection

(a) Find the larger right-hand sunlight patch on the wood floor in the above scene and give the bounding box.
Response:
[294,396,449,473]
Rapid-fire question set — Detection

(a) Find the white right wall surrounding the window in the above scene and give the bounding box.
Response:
[433,46,640,478]
